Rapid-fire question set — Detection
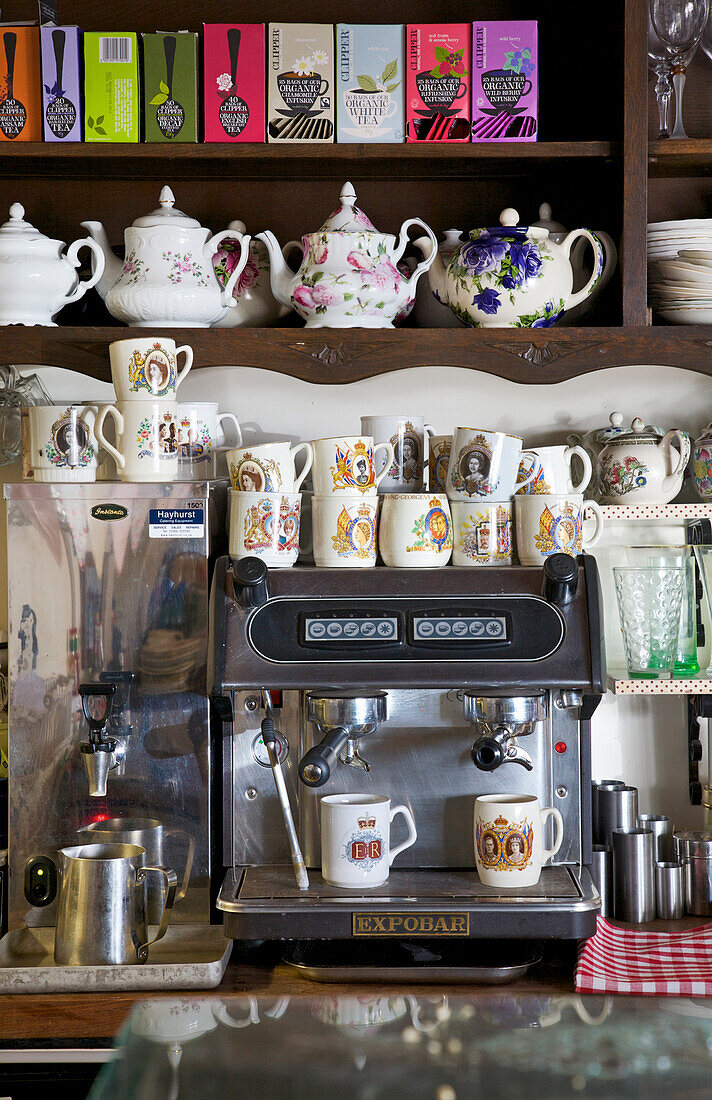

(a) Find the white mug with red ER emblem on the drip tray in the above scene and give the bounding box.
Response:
[319,794,418,890]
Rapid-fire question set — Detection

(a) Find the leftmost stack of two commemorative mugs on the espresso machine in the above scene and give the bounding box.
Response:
[226,440,314,569]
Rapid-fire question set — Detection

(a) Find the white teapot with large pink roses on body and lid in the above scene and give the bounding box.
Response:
[258,184,437,329]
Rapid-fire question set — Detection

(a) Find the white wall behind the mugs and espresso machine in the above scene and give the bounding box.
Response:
[6,360,712,824]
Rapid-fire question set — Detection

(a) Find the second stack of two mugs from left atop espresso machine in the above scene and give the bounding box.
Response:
[311,436,393,569]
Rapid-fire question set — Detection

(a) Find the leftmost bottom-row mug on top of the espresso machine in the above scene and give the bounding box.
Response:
[229,490,302,569]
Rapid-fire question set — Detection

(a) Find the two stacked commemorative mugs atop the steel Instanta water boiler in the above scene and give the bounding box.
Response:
[96,336,193,482]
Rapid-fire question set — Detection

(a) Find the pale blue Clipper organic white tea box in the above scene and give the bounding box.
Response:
[336,23,405,142]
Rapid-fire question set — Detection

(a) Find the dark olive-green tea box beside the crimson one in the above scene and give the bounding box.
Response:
[141,34,198,142]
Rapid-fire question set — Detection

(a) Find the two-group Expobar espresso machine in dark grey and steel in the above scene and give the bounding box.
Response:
[211,554,605,977]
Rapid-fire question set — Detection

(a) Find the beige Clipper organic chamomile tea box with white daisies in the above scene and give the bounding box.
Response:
[267,23,335,142]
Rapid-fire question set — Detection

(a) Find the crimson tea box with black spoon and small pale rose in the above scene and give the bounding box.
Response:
[202,23,265,142]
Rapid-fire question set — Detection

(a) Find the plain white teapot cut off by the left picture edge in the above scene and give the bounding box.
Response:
[0,202,103,326]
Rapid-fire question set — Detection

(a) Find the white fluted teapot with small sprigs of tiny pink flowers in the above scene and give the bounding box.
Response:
[81,187,250,329]
